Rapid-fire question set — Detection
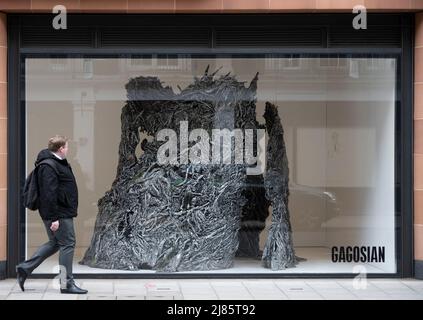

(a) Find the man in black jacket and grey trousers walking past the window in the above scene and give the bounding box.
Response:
[16,135,88,294]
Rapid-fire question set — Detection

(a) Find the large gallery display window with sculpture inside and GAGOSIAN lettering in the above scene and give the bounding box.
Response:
[23,54,398,274]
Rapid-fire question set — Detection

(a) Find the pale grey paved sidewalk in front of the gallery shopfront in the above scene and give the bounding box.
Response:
[0,279,423,300]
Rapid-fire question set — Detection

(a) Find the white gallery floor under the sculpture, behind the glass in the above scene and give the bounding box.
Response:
[29,247,392,276]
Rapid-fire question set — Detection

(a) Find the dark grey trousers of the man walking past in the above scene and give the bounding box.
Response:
[18,218,75,285]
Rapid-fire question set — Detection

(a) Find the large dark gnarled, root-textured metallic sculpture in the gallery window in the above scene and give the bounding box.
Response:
[81,70,297,271]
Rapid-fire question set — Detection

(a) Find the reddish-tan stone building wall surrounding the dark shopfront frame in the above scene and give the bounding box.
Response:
[0,0,423,277]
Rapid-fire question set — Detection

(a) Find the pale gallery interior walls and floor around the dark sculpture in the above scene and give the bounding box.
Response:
[25,54,397,274]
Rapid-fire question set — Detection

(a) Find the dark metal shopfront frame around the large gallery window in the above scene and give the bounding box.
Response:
[7,14,414,278]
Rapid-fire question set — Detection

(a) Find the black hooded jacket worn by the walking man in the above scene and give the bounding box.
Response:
[35,149,78,221]
